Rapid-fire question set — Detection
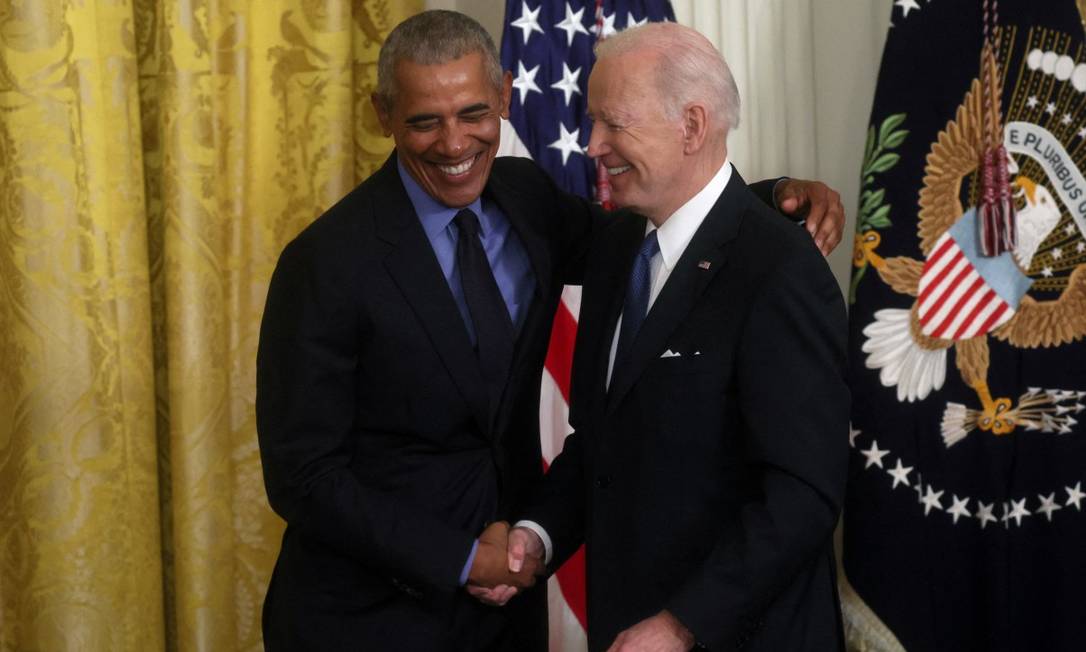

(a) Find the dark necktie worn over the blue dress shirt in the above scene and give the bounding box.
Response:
[453,209,513,385]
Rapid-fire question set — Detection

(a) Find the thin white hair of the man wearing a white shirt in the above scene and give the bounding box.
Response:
[596,23,740,130]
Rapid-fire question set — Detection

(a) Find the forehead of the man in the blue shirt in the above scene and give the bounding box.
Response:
[394,52,497,112]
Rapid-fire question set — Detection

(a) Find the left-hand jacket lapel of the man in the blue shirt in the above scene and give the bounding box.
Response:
[374,154,492,437]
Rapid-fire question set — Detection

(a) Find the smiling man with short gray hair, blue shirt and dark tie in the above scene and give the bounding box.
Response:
[256,11,842,651]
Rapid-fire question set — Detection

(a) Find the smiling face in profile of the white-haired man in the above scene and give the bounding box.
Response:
[589,52,689,224]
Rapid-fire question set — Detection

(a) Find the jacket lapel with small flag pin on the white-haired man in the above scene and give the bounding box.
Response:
[607,170,750,412]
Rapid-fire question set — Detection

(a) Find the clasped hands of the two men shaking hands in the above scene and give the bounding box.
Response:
[467,521,544,606]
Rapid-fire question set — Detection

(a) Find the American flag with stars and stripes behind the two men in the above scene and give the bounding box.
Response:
[500,0,674,652]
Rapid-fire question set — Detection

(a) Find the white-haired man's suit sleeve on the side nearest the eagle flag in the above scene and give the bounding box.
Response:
[667,247,849,649]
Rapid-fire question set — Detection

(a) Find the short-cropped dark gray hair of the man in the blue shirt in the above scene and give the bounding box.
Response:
[376,9,502,109]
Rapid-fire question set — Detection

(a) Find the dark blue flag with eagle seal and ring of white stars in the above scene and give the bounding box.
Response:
[843,0,1086,651]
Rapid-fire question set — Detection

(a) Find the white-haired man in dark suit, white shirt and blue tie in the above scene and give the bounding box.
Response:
[509,23,849,652]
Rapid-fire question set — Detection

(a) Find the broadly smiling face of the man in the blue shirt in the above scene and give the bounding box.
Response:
[374,52,513,208]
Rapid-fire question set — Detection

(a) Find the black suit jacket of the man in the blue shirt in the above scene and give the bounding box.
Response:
[256,155,590,650]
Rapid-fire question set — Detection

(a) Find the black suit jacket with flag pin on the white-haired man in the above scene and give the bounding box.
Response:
[525,173,848,652]
